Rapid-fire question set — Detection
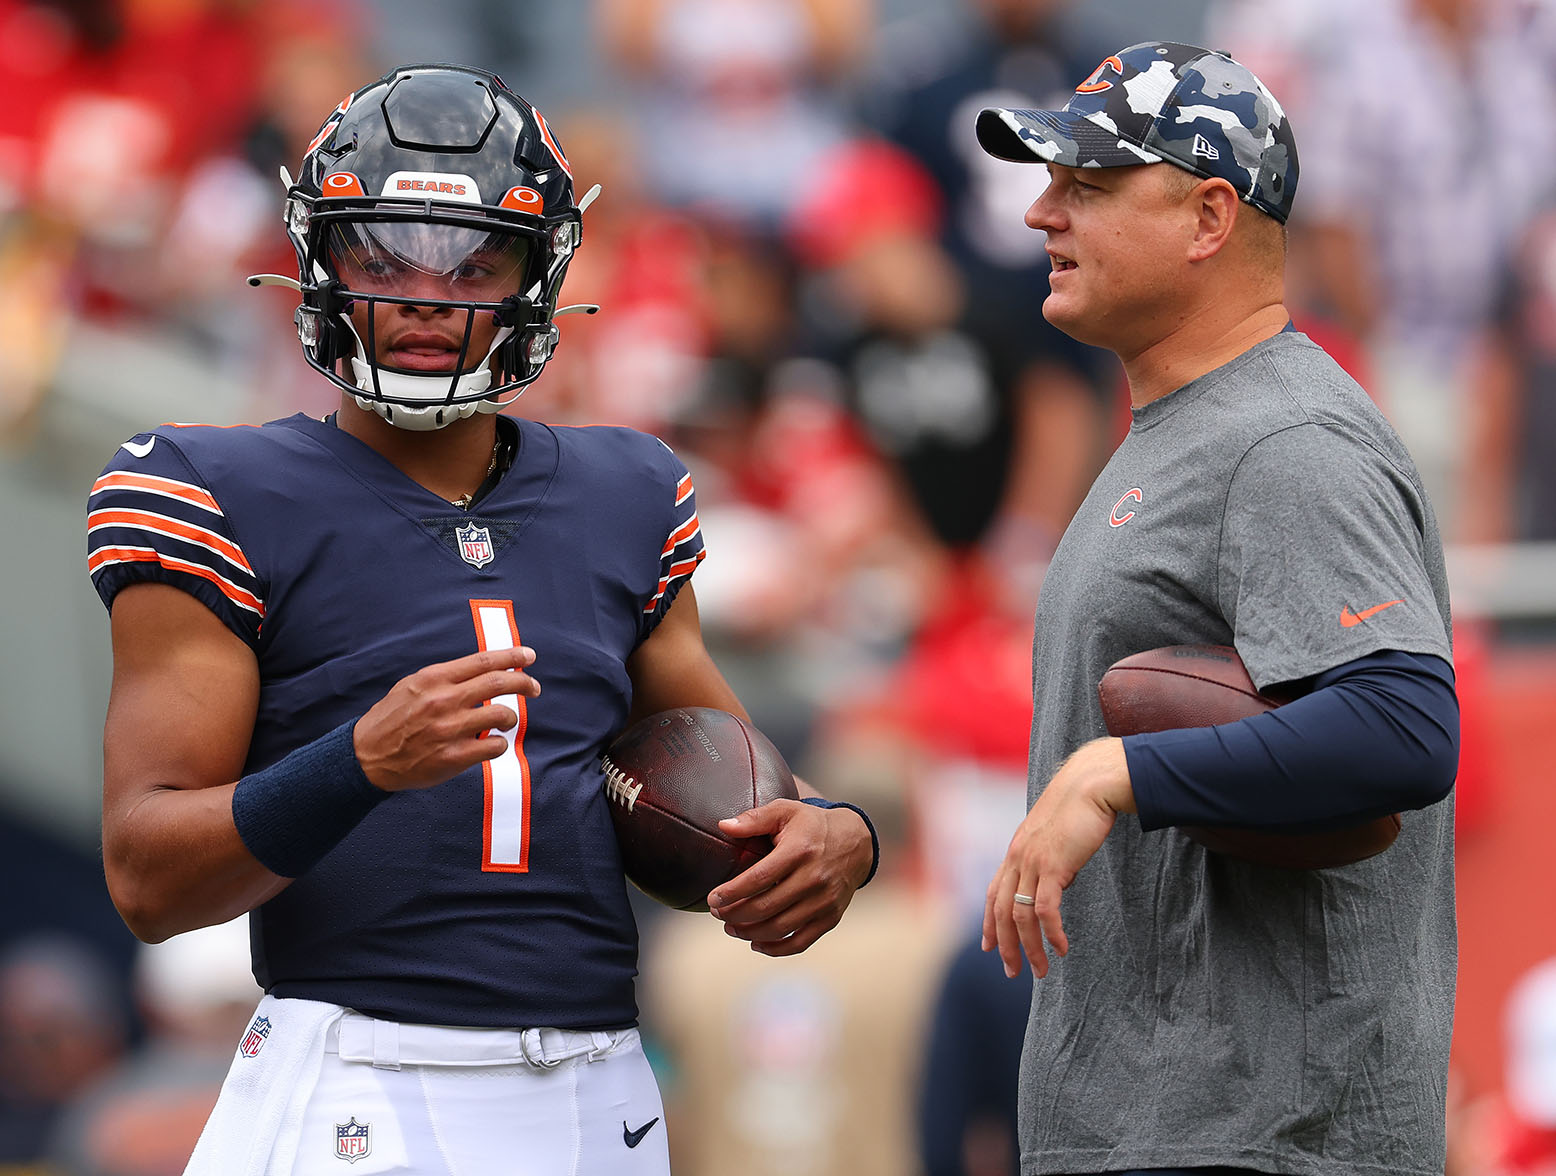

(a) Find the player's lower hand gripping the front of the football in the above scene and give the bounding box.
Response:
[708,800,871,955]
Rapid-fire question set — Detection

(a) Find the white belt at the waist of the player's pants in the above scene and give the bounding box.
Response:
[324,1011,638,1070]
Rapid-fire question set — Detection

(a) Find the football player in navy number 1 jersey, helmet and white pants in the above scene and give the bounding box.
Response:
[89,65,874,1176]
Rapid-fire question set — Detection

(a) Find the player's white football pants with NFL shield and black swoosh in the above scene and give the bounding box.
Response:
[185,997,669,1176]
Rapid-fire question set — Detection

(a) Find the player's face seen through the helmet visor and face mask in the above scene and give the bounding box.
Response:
[330,222,529,372]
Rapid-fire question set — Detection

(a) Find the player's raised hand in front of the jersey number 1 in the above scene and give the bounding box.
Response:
[352,646,540,792]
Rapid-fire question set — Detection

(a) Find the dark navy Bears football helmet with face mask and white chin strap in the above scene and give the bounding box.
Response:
[264,65,594,429]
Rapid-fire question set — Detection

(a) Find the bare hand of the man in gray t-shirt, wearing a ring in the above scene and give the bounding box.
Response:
[983,739,1134,977]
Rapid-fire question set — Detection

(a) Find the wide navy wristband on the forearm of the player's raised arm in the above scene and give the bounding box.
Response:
[232,719,389,877]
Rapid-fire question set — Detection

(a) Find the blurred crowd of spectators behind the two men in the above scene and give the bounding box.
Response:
[0,0,1556,1176]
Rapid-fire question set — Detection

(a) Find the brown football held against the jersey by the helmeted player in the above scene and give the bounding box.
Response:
[602,706,800,910]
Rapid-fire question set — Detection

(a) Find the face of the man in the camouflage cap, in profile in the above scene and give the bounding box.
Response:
[1025,163,1189,355]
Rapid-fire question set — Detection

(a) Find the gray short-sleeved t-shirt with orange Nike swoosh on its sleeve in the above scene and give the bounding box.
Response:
[1019,331,1456,1176]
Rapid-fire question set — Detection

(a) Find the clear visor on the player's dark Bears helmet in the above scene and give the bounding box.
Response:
[325,221,532,302]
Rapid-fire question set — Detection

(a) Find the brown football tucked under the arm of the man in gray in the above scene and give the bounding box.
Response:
[1097,646,1399,870]
